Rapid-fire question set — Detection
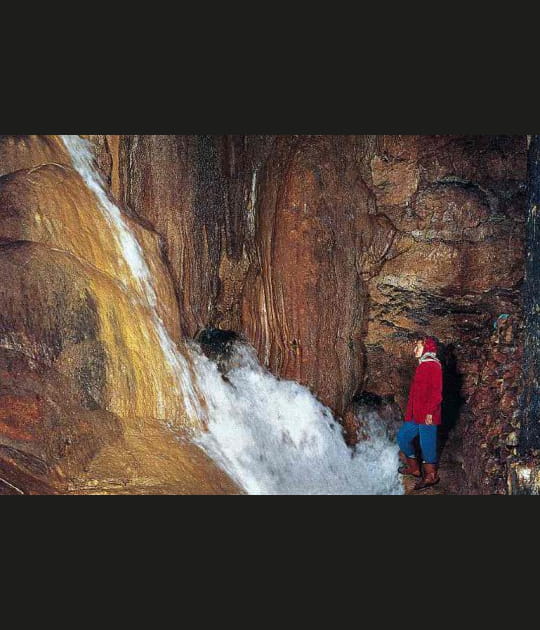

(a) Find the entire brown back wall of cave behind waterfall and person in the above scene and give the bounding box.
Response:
[116,136,527,430]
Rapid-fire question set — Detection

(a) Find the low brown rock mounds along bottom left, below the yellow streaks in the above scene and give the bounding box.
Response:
[0,349,239,494]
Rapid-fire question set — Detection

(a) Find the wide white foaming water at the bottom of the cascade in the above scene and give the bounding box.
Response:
[192,345,403,494]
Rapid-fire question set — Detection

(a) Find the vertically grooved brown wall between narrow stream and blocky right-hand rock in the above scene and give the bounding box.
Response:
[120,136,394,412]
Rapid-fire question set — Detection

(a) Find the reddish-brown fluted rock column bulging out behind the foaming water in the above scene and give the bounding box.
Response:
[242,136,392,413]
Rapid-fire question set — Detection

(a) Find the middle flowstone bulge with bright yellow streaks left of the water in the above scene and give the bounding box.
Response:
[0,243,200,427]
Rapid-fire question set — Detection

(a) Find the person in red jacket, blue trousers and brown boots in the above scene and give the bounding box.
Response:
[397,337,442,490]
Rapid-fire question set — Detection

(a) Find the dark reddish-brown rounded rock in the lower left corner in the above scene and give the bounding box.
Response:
[0,348,121,490]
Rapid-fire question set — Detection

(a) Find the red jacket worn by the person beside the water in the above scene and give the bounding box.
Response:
[404,361,442,425]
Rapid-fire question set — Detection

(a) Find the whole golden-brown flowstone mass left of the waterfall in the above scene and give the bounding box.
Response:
[0,137,238,492]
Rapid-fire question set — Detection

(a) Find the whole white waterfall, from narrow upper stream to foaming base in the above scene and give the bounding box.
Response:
[62,136,403,494]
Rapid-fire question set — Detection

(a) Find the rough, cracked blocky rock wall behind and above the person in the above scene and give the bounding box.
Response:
[366,136,527,494]
